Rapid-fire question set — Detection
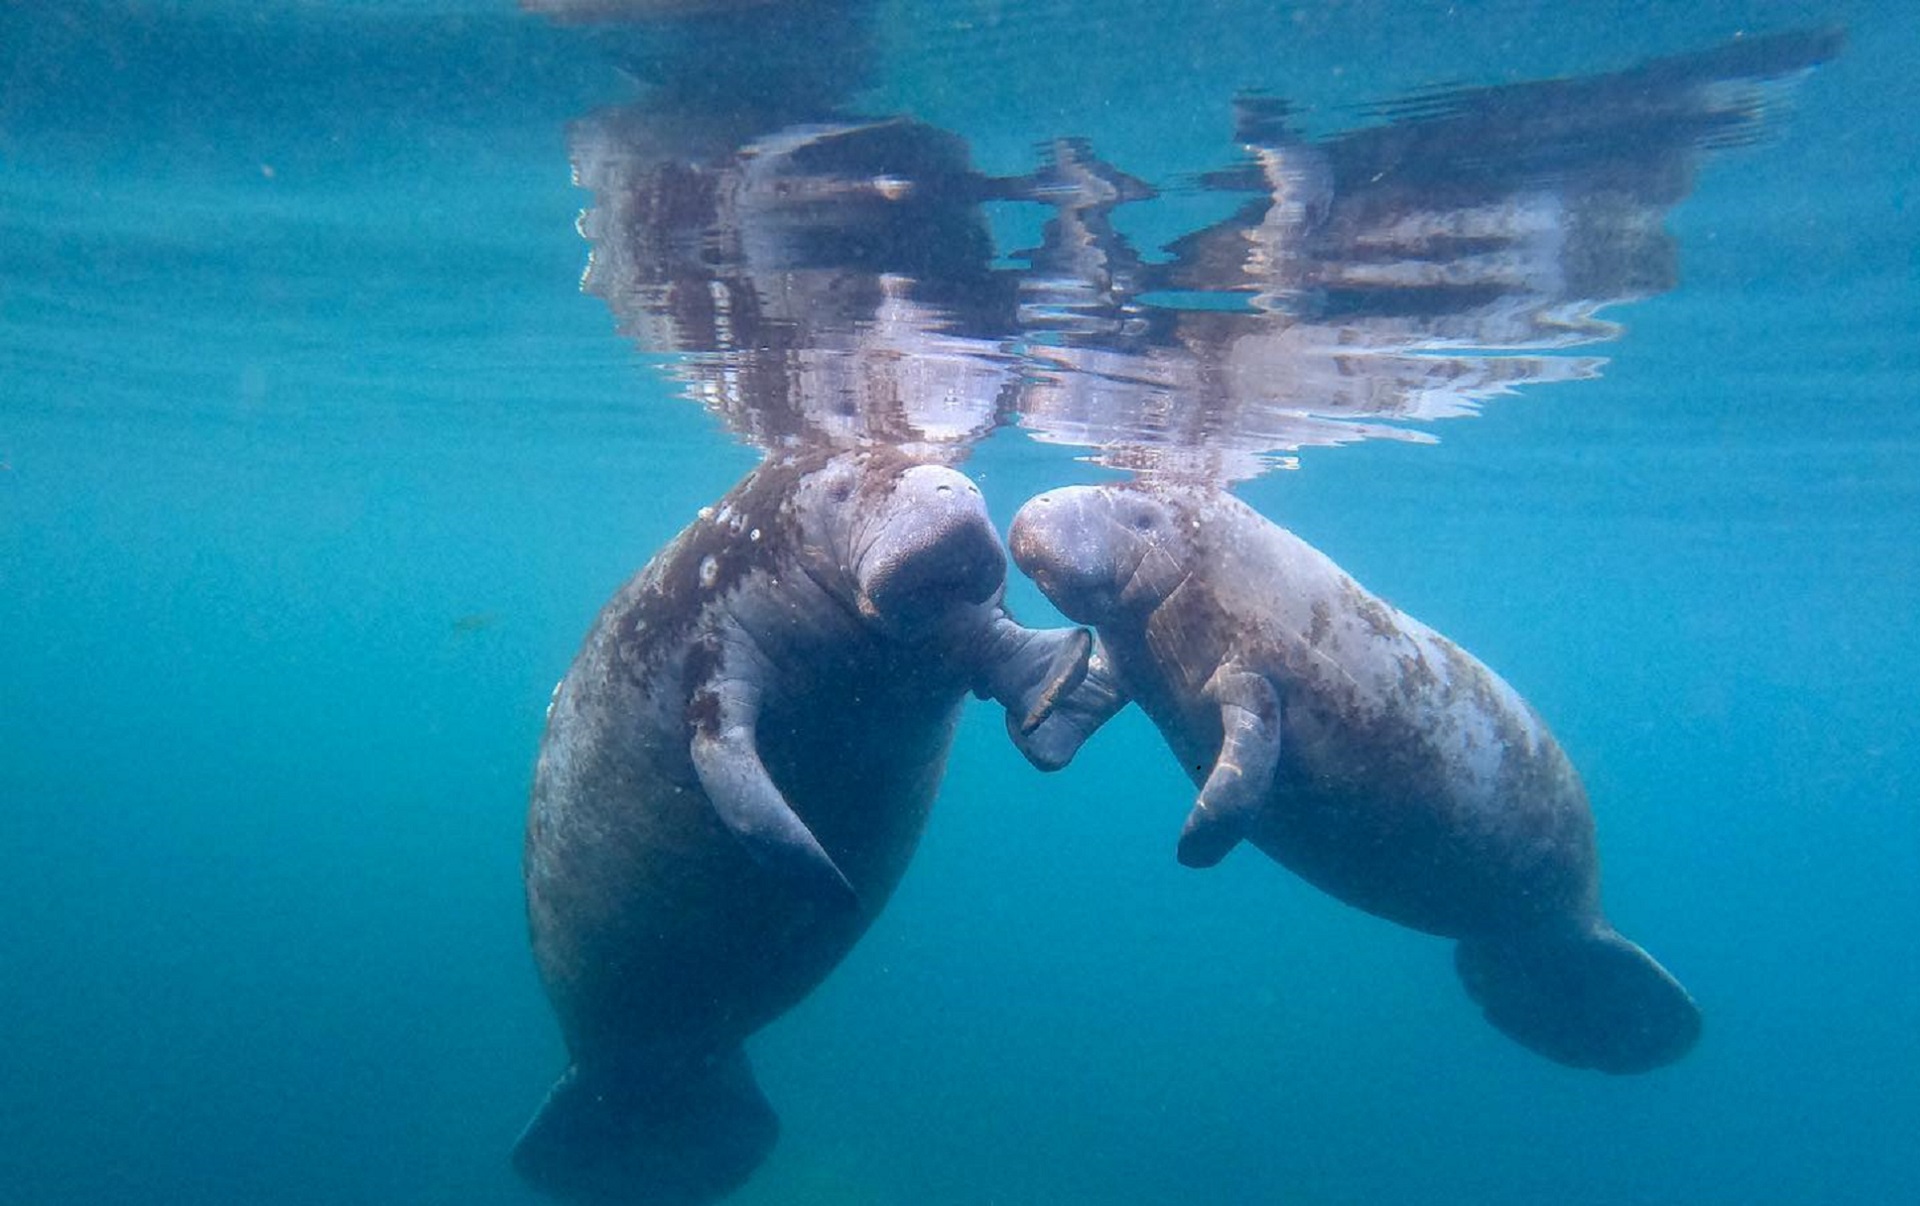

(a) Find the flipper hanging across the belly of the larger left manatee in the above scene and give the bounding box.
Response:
[691,680,854,905]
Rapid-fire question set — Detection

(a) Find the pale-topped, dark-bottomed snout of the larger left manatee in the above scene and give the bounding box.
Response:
[856,465,1006,630]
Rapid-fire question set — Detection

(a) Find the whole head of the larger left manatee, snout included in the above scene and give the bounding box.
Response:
[829,457,1006,639]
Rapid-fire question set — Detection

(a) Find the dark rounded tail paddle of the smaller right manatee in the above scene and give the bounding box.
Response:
[1453,922,1699,1075]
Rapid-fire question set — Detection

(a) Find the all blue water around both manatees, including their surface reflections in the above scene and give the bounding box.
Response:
[0,0,1920,1206]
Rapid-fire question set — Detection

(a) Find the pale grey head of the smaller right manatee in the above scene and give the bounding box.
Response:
[1008,486,1190,626]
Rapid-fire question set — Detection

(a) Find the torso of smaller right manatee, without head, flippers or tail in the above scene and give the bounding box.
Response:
[1183,497,1596,935]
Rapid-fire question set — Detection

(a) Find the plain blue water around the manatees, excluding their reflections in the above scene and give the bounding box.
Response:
[0,0,1920,1206]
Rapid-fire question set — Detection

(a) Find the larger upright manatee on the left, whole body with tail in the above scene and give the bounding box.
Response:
[515,449,1092,1202]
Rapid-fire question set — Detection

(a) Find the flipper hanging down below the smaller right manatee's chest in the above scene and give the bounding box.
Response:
[1179,663,1281,866]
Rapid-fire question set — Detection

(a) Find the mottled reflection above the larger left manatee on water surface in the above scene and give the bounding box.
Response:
[568,106,1020,463]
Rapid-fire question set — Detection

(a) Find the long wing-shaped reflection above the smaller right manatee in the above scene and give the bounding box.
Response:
[1018,31,1841,482]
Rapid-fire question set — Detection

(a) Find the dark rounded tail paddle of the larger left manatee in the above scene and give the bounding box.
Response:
[513,1047,780,1206]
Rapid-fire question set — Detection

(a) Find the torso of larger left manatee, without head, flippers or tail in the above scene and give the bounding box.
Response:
[526,449,952,1060]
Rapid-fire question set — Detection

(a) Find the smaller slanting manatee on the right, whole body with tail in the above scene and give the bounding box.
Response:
[1010,482,1699,1073]
